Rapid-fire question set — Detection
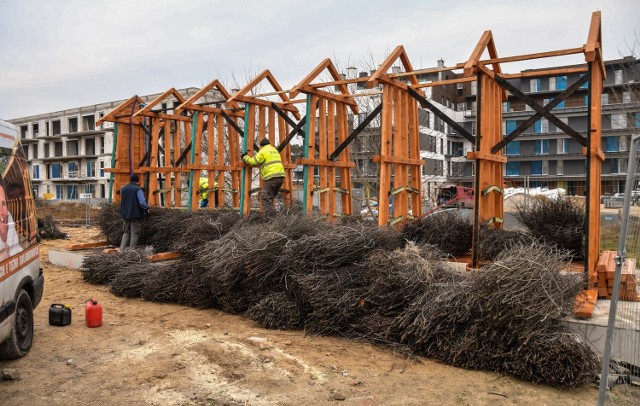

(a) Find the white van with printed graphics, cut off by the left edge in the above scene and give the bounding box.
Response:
[0,120,44,359]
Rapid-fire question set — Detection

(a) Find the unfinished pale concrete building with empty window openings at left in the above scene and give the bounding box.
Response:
[9,88,198,200]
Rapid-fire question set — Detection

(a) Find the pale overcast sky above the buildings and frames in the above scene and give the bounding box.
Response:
[0,0,640,119]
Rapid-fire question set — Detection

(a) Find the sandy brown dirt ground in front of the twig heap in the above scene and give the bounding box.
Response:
[0,219,637,406]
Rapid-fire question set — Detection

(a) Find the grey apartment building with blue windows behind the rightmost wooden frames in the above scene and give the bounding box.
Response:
[448,56,640,195]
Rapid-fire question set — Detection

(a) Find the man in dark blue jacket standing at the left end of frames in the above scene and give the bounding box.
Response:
[120,173,149,251]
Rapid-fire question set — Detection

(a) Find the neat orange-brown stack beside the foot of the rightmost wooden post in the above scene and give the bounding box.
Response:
[596,251,640,302]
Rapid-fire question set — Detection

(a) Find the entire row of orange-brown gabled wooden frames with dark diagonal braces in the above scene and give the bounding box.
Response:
[98,12,605,294]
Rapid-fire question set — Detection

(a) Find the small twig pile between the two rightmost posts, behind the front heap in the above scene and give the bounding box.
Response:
[515,198,586,259]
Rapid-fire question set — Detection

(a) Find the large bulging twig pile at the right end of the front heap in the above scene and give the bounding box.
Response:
[395,243,598,387]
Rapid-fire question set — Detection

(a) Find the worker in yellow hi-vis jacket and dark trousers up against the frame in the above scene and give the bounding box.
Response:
[242,138,285,217]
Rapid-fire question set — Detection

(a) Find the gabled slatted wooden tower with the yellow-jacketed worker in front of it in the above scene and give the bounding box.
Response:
[227,70,300,215]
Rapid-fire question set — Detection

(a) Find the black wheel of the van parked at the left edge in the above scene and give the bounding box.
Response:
[0,289,33,359]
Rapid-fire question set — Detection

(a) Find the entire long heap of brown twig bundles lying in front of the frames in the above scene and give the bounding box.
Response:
[83,213,598,387]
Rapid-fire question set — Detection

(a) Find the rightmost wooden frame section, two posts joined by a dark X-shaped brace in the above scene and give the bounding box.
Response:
[464,12,605,288]
